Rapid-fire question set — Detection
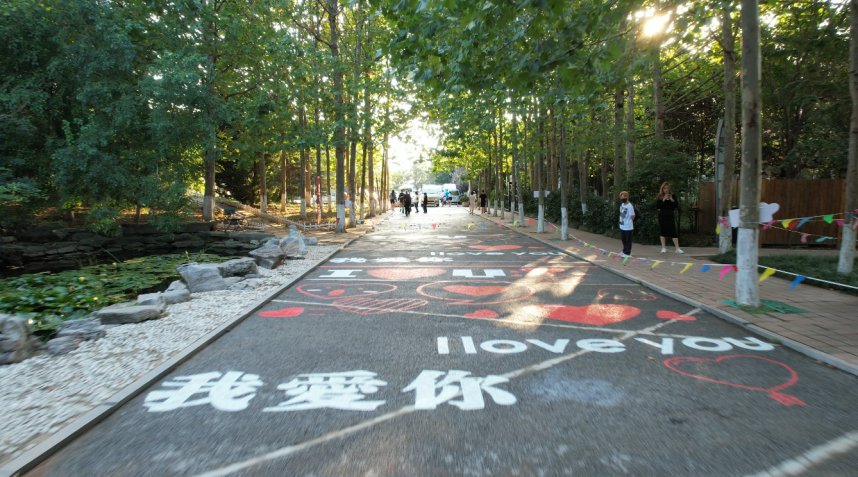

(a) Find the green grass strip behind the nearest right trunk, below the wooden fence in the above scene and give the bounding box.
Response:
[709,250,858,295]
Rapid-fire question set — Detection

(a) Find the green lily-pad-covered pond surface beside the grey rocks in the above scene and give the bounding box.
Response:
[0,253,241,338]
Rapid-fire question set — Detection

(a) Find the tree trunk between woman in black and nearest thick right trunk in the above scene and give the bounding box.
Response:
[716,2,736,253]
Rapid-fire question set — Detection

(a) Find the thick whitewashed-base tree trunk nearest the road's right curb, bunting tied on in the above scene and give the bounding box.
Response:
[736,0,762,307]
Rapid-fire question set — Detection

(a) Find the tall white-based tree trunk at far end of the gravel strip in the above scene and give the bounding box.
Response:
[326,0,346,233]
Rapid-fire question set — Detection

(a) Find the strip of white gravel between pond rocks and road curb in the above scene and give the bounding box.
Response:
[0,245,337,464]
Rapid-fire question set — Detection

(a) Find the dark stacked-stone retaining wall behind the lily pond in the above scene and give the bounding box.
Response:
[0,223,273,275]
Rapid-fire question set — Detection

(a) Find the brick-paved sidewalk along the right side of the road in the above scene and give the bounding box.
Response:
[475,213,858,375]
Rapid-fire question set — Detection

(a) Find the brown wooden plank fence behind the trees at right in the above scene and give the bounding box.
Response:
[697,179,846,247]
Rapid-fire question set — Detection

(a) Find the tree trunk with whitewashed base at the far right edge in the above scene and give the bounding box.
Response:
[837,0,858,275]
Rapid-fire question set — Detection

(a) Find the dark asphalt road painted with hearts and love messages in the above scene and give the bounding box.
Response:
[26,208,858,477]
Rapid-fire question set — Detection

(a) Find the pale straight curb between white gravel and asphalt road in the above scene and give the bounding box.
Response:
[0,233,365,477]
